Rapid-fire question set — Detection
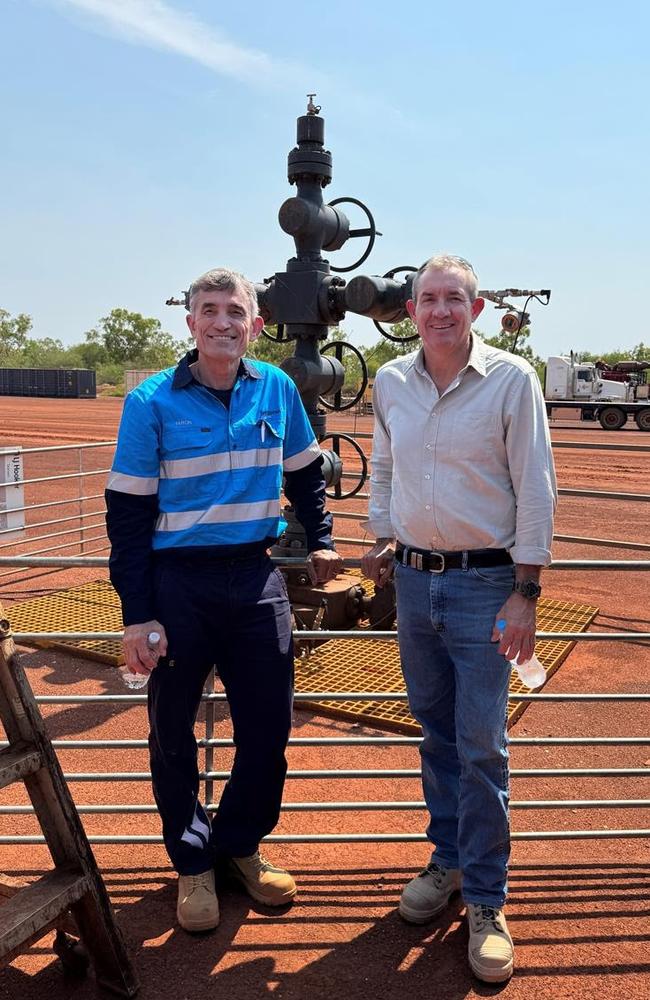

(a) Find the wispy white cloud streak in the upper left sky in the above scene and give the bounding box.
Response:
[51,0,306,86]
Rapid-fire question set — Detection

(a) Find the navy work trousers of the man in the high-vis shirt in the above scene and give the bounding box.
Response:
[149,555,293,875]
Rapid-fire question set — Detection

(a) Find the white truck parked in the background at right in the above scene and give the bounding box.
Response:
[544,352,650,431]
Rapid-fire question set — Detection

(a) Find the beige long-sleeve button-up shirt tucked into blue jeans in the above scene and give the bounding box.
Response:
[366,334,557,566]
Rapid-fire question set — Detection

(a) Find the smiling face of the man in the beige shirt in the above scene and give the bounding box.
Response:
[406,269,485,356]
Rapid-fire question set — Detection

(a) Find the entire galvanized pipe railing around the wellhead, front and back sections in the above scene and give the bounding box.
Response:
[0,433,650,844]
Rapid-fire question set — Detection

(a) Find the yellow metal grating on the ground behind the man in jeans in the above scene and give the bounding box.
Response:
[296,599,598,735]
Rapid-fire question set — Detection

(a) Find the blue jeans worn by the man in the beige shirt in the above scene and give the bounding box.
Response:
[395,565,514,907]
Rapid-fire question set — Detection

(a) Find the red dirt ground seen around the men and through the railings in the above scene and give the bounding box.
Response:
[0,398,650,1000]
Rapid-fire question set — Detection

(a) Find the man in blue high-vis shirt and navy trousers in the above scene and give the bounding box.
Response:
[106,269,342,932]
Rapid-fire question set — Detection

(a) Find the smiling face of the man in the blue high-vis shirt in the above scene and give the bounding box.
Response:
[187,288,264,363]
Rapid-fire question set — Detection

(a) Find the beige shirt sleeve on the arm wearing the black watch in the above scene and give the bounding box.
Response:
[506,372,557,566]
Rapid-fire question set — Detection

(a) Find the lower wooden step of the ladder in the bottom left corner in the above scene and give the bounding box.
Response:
[0,865,90,964]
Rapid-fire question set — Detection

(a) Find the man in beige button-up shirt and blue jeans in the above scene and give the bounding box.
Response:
[363,257,556,982]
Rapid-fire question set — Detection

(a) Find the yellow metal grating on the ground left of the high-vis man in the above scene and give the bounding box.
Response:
[7,580,124,666]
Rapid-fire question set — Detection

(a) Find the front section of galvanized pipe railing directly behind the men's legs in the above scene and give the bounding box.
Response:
[0,557,650,844]
